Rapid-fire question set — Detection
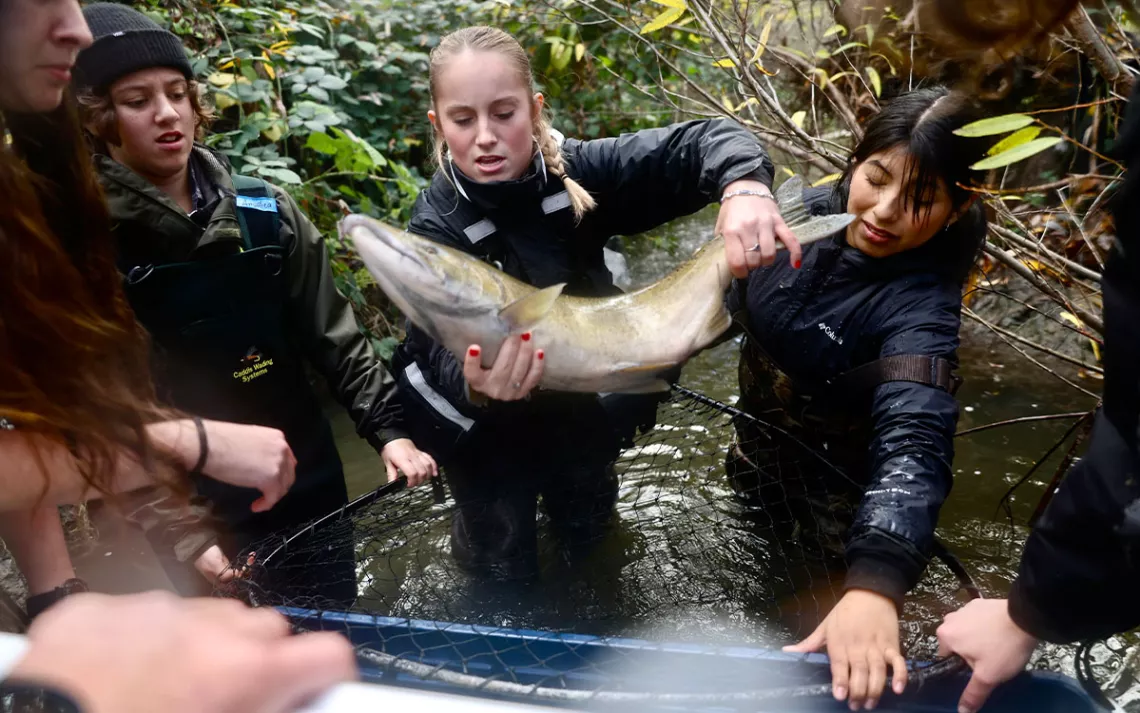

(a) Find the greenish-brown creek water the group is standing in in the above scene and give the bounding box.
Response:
[66,204,1140,711]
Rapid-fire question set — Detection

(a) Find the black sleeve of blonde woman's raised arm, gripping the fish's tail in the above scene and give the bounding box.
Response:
[563,119,774,237]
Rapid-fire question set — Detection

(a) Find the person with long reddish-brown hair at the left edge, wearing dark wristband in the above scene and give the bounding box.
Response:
[0,0,294,614]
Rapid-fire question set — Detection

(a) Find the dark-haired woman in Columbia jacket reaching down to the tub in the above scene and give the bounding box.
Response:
[726,87,986,710]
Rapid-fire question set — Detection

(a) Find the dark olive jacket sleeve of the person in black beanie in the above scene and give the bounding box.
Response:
[278,192,407,452]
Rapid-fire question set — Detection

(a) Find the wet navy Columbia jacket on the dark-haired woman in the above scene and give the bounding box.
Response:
[728,188,962,602]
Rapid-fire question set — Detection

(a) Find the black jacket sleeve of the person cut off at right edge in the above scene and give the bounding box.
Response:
[1009,83,1140,643]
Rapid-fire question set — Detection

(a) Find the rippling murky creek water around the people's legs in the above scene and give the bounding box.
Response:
[316,205,1135,699]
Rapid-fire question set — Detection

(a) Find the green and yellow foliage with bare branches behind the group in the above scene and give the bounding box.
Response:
[132,0,1137,392]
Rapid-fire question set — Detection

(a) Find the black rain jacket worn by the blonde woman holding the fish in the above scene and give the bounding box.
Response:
[393,114,773,460]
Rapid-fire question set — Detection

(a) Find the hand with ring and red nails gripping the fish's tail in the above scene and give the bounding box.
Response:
[716,180,803,278]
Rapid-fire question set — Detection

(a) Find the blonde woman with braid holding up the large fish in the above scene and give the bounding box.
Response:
[393,27,799,580]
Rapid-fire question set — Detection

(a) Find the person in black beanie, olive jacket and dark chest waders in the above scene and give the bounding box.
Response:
[68,3,435,600]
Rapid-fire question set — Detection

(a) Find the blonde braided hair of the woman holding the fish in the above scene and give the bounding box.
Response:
[429,25,595,219]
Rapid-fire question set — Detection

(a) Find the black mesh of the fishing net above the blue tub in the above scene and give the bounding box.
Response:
[226,389,966,700]
